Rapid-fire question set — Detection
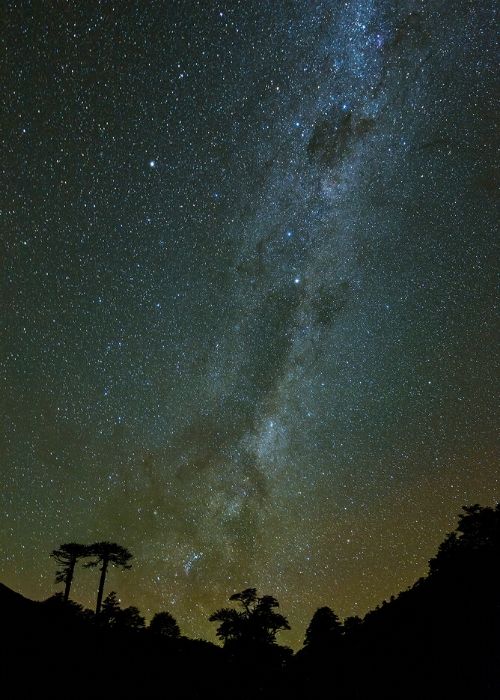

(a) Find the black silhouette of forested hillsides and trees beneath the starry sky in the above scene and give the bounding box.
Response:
[0,503,500,700]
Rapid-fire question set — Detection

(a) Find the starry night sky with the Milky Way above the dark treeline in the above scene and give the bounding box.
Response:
[0,0,500,647]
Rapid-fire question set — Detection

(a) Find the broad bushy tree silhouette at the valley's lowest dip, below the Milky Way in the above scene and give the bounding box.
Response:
[209,588,290,645]
